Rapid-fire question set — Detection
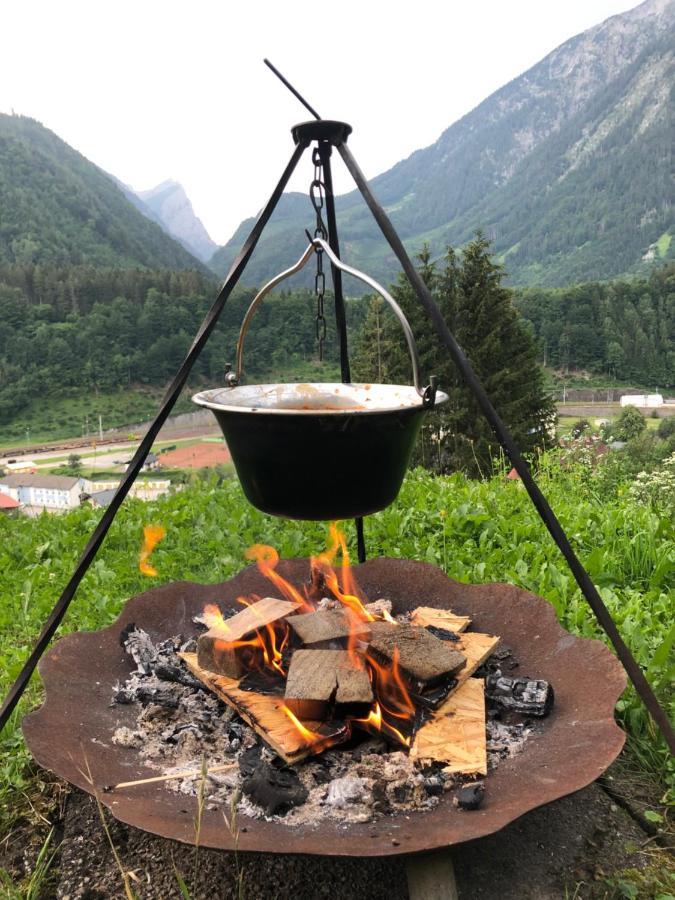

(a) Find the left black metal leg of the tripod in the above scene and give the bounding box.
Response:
[0,142,307,731]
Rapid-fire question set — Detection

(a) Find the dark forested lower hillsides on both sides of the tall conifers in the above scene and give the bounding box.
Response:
[0,255,675,444]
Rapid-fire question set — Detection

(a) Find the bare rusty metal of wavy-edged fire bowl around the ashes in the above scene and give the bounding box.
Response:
[23,559,626,857]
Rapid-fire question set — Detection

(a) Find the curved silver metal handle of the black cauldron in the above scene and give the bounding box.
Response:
[230,238,436,407]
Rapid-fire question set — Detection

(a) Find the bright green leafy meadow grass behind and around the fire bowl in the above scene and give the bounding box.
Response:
[0,454,675,888]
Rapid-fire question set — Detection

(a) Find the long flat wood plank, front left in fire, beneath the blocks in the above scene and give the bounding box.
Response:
[179,653,350,763]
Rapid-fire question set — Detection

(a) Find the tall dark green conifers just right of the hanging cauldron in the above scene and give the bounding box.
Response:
[357,233,554,476]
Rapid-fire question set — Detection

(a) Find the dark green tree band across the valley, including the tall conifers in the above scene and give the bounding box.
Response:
[0,253,675,450]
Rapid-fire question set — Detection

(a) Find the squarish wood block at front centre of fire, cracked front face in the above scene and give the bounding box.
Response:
[285,650,374,719]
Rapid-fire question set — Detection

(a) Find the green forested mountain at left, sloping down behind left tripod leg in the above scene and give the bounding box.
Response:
[0,114,203,269]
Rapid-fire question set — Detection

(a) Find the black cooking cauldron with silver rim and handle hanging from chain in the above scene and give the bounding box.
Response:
[192,238,448,520]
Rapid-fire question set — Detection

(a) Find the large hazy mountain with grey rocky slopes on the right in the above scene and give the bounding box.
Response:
[210,0,675,286]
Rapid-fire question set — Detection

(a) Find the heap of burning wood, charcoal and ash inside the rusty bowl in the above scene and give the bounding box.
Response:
[113,595,553,825]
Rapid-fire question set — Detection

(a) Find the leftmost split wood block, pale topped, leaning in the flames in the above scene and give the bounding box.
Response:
[197,597,298,678]
